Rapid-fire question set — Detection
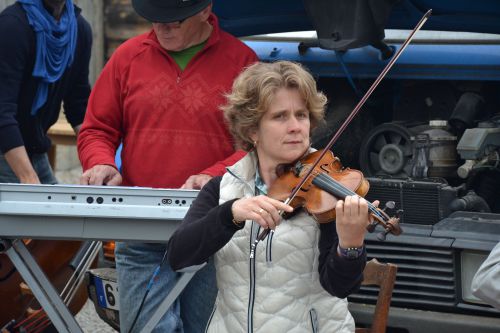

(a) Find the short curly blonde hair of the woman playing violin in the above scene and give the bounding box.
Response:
[221,61,327,151]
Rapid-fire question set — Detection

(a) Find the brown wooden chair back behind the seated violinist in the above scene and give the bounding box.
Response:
[356,259,398,333]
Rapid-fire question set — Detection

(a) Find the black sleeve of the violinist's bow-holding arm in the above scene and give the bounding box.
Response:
[167,177,244,270]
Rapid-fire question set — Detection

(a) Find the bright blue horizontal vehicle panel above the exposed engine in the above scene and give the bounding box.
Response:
[246,40,500,81]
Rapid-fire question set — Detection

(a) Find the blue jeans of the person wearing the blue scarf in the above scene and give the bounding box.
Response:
[0,153,57,184]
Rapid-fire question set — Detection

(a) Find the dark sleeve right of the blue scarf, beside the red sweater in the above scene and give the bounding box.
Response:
[63,15,92,127]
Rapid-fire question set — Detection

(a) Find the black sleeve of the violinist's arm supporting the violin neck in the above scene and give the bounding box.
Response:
[318,222,366,298]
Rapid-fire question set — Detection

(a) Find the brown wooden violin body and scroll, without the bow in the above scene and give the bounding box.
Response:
[268,150,402,240]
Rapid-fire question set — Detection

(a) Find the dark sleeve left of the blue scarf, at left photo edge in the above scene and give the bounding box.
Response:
[0,13,29,153]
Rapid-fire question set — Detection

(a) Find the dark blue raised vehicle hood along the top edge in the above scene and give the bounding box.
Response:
[214,0,500,36]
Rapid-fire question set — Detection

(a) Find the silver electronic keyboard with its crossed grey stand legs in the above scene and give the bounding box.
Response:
[0,183,205,333]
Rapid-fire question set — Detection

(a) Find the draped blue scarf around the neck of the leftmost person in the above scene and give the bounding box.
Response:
[18,0,77,115]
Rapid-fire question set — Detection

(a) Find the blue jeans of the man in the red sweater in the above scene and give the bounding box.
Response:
[115,241,217,333]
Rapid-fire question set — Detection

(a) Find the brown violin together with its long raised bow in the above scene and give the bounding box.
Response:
[250,9,432,254]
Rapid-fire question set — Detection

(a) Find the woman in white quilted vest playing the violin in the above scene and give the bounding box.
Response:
[168,61,376,333]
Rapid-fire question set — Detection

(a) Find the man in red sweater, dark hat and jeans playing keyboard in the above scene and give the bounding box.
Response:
[78,0,257,332]
